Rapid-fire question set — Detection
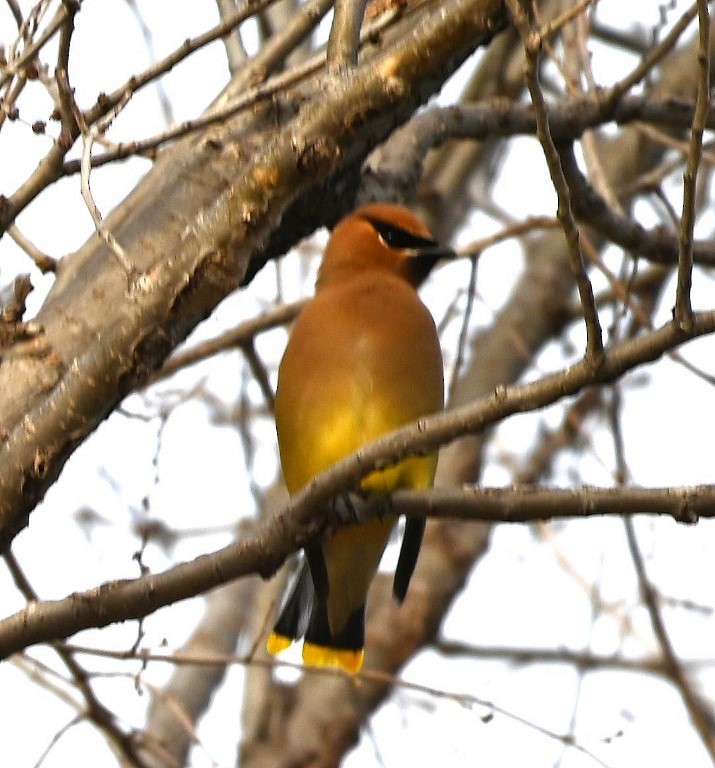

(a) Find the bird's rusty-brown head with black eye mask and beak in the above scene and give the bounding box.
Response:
[318,203,455,288]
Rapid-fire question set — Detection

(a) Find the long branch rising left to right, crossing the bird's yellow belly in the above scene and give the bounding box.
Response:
[0,312,715,658]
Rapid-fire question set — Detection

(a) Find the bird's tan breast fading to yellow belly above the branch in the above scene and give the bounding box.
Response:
[276,279,443,493]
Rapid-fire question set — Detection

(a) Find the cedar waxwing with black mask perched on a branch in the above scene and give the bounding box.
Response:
[268,203,454,672]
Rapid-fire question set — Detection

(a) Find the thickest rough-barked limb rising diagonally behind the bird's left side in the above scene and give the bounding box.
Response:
[0,0,505,548]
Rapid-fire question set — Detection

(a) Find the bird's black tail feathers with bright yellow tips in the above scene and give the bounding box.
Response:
[266,558,365,673]
